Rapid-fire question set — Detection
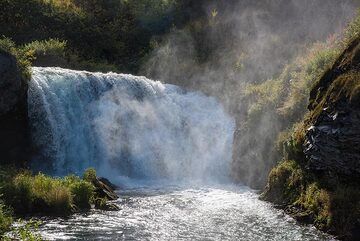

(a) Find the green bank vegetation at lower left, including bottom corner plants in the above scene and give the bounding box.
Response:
[0,167,111,237]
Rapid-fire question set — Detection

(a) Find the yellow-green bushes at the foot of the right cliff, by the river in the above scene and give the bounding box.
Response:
[262,157,360,235]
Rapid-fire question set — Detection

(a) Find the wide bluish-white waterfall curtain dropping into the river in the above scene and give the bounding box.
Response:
[28,67,235,184]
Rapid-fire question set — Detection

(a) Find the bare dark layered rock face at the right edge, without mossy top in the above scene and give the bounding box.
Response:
[304,101,360,177]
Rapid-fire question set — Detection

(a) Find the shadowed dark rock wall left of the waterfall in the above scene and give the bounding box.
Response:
[0,51,29,164]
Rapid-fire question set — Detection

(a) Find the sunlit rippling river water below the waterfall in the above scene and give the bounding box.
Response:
[40,186,333,241]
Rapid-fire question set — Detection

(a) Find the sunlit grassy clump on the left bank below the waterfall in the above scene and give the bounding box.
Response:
[0,169,96,216]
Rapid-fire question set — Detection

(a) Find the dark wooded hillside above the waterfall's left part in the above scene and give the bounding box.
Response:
[0,0,186,72]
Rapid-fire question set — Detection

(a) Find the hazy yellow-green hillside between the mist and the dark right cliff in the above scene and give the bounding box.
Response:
[233,35,341,187]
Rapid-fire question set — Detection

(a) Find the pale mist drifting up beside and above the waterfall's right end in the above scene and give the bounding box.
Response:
[140,0,359,188]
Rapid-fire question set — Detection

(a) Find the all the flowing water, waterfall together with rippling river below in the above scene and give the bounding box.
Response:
[29,68,331,241]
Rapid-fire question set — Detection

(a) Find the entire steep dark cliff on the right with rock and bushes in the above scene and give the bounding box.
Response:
[262,38,360,240]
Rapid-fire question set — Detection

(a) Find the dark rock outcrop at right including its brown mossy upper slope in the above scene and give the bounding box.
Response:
[304,39,360,181]
